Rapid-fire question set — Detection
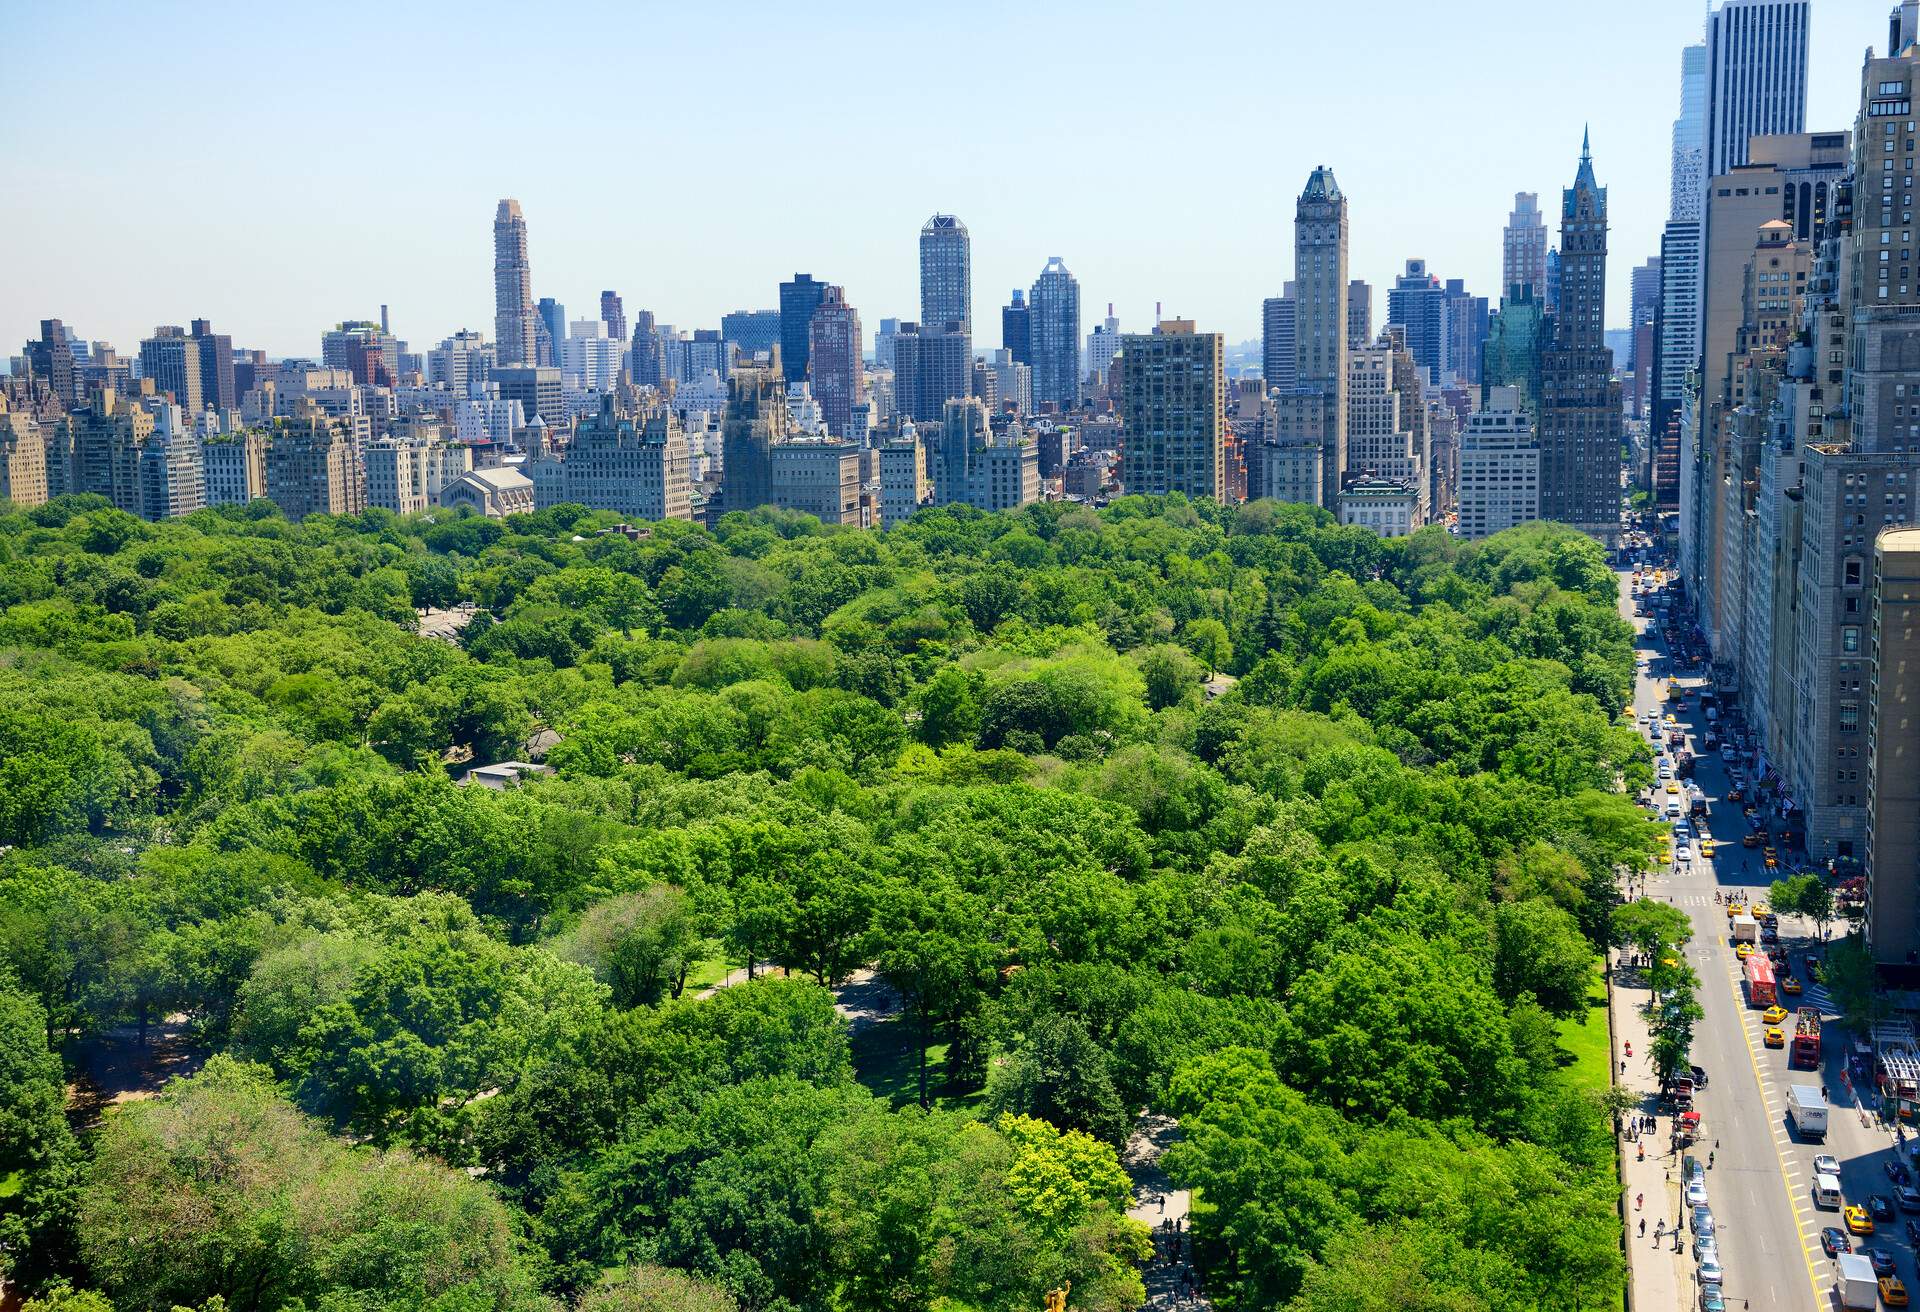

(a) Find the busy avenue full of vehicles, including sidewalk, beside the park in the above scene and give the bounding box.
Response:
[1617,547,1920,1312]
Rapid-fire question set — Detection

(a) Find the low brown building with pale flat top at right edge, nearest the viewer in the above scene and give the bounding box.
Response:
[1864,526,1920,966]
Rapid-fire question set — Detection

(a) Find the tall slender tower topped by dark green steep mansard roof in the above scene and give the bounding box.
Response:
[1294,165,1352,509]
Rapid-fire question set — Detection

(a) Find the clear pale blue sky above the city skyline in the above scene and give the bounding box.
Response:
[0,0,1891,359]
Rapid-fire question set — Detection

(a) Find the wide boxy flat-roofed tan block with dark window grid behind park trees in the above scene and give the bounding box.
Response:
[1119,319,1227,499]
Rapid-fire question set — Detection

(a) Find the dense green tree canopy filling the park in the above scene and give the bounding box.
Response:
[0,498,1651,1312]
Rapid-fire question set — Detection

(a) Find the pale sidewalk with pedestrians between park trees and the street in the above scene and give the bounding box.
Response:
[1607,951,1693,1312]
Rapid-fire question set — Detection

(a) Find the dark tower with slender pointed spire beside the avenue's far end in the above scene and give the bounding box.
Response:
[1540,136,1622,544]
